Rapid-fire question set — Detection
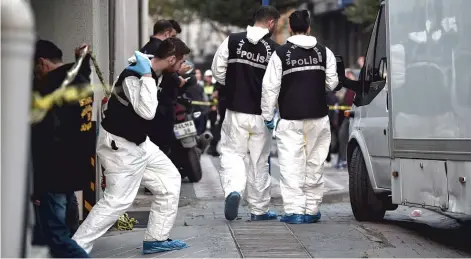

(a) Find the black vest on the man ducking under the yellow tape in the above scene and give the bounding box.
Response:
[101,69,156,145]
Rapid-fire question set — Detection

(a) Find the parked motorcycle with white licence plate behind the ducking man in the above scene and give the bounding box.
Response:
[169,96,212,183]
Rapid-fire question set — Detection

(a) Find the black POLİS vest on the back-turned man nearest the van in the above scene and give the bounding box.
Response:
[276,42,329,120]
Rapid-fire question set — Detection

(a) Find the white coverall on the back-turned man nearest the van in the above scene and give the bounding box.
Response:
[261,35,338,215]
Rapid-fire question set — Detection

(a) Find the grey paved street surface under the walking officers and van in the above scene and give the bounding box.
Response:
[91,156,471,258]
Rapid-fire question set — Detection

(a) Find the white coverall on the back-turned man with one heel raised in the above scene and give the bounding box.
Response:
[211,26,272,215]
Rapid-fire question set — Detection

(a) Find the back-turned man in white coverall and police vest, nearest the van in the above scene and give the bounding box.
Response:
[261,10,338,224]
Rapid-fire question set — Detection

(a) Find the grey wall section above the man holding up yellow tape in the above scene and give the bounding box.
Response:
[31,0,109,120]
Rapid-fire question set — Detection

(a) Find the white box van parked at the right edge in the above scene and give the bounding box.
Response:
[342,0,471,221]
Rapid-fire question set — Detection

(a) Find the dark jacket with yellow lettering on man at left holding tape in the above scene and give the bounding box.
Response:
[31,57,96,195]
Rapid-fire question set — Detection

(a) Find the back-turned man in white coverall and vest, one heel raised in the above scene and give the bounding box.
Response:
[212,6,280,220]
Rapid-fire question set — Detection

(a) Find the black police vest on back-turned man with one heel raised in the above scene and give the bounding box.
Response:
[224,32,279,115]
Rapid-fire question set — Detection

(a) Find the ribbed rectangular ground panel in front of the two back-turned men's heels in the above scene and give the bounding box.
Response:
[228,221,311,258]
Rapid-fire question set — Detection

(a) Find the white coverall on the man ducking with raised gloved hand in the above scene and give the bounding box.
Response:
[73,73,181,253]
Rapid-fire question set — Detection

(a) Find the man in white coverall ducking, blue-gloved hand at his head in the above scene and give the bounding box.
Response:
[73,38,190,254]
